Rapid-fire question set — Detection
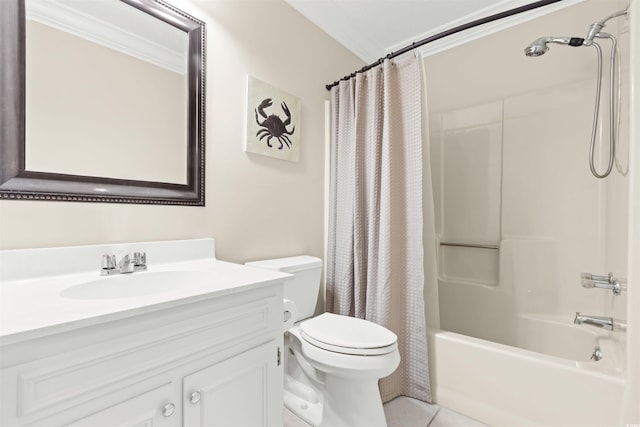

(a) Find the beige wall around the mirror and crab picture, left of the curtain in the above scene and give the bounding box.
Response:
[0,0,363,268]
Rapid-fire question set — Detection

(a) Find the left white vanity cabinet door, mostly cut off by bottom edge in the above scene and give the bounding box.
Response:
[67,383,181,427]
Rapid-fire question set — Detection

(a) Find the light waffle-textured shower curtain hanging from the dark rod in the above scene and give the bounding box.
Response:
[327,58,431,402]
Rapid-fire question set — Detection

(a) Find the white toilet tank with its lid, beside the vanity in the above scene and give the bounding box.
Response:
[245,255,322,321]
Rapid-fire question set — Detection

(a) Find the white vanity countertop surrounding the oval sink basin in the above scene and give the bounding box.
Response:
[0,241,291,345]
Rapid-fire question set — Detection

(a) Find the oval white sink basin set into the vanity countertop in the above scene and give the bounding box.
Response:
[60,271,213,300]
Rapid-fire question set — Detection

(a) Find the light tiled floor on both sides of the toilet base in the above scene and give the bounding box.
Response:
[284,396,487,427]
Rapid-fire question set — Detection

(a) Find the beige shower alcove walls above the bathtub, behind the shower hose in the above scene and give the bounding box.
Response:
[425,1,629,352]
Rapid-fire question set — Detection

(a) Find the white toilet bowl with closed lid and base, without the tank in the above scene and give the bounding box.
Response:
[285,313,400,427]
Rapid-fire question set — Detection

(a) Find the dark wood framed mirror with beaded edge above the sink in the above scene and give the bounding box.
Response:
[0,0,206,206]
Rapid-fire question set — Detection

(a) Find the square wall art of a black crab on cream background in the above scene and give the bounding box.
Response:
[245,76,300,162]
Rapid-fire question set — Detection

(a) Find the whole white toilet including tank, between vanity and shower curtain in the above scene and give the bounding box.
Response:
[247,255,400,427]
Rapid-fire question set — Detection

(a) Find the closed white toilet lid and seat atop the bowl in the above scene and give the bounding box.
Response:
[300,313,398,355]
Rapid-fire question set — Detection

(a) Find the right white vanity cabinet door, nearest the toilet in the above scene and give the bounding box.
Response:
[183,341,282,427]
